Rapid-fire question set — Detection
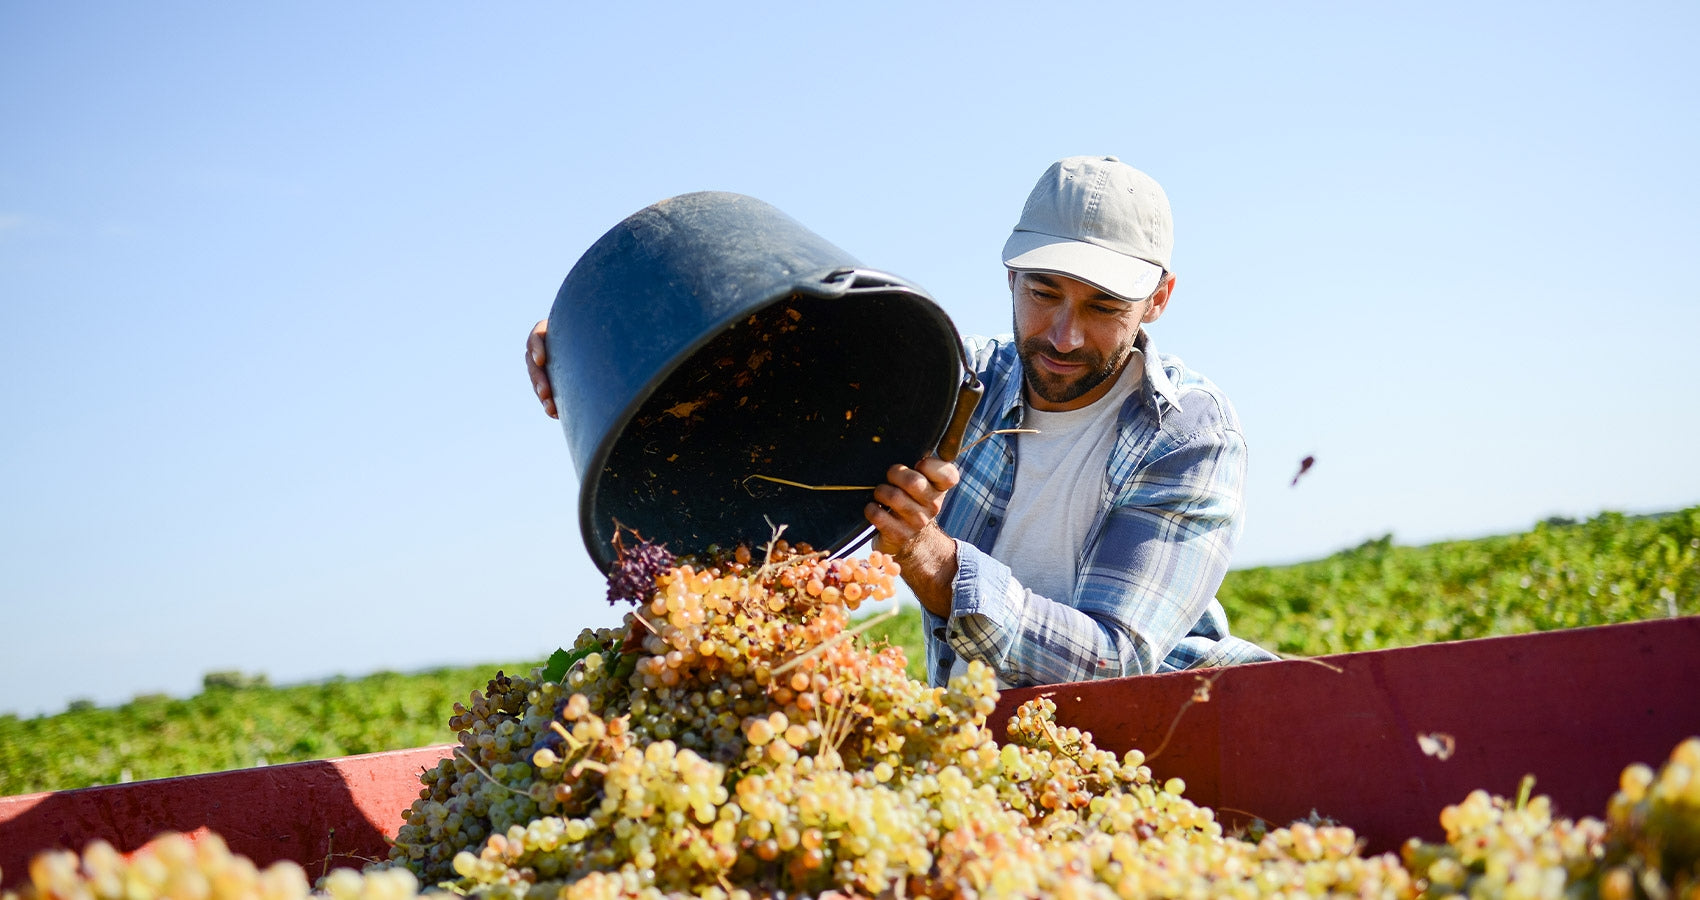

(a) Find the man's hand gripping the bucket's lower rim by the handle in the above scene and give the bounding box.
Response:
[864,456,962,618]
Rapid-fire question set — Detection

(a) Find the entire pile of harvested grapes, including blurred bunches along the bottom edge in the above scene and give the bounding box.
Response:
[3,541,1700,900]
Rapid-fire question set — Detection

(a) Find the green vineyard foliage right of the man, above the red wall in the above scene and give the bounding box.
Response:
[1217,507,1700,657]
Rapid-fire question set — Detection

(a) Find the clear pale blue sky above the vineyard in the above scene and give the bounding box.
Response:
[0,2,1700,715]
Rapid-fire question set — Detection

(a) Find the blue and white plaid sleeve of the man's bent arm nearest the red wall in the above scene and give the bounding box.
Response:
[945,421,1246,684]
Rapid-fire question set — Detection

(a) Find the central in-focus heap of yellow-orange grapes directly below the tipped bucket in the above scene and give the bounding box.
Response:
[372,541,1434,900]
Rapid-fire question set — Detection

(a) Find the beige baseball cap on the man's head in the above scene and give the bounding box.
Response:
[1003,157,1175,299]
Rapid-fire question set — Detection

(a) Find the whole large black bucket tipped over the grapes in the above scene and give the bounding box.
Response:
[547,191,979,572]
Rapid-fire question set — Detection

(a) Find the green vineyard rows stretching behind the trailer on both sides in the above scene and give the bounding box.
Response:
[0,507,1700,795]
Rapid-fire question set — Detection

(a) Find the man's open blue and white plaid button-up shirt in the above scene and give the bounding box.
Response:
[923,333,1275,686]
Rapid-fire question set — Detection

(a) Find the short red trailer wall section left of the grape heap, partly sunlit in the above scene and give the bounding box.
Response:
[0,745,454,888]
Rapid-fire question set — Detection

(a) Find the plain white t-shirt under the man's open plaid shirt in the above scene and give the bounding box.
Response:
[950,349,1146,689]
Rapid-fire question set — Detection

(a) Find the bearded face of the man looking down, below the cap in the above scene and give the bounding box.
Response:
[1010,272,1170,412]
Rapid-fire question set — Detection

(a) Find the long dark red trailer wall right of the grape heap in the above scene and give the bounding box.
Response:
[993,616,1700,851]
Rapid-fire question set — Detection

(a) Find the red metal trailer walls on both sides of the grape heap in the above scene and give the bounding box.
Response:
[0,616,1700,886]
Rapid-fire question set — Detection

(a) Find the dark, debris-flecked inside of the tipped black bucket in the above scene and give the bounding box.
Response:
[581,289,961,568]
